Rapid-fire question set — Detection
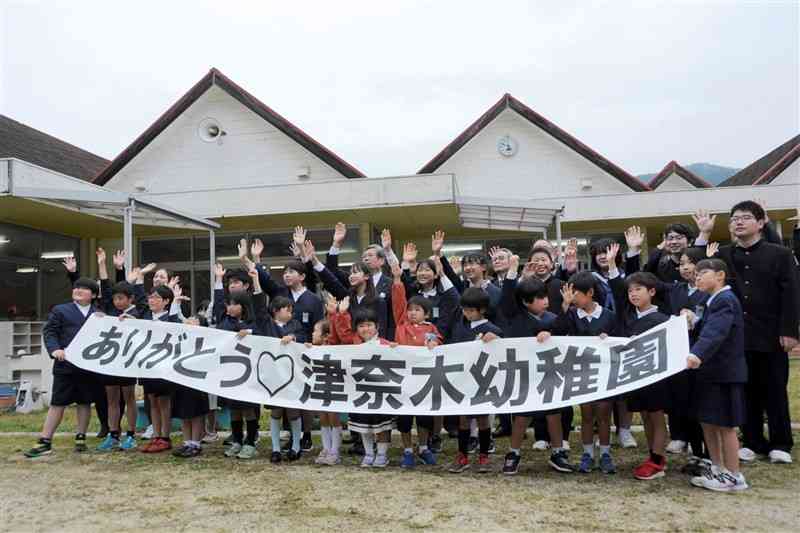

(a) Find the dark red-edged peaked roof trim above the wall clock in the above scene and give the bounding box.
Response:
[417,93,650,191]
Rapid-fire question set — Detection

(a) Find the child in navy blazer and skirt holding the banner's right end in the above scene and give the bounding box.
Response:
[687,259,748,492]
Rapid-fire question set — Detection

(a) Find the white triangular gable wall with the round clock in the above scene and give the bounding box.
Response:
[437,109,631,199]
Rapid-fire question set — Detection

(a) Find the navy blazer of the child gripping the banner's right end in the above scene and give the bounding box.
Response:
[691,290,747,383]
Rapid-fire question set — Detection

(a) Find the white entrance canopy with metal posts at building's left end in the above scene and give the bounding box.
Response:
[0,159,220,280]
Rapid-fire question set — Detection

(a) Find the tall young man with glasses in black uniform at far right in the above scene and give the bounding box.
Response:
[695,201,800,463]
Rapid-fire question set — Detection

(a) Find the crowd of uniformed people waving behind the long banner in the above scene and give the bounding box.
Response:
[27,202,798,491]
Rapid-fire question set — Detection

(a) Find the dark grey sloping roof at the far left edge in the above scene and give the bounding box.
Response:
[0,115,108,181]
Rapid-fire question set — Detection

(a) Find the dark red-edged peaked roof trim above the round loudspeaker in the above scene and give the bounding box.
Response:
[94,68,366,185]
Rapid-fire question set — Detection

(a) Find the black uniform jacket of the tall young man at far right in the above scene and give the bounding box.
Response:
[718,239,800,352]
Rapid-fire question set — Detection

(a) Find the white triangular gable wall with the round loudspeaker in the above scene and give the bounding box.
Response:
[106,86,344,197]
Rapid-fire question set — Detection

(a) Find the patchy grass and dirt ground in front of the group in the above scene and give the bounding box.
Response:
[0,434,800,532]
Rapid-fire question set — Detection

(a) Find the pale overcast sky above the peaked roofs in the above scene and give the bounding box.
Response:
[0,0,800,176]
